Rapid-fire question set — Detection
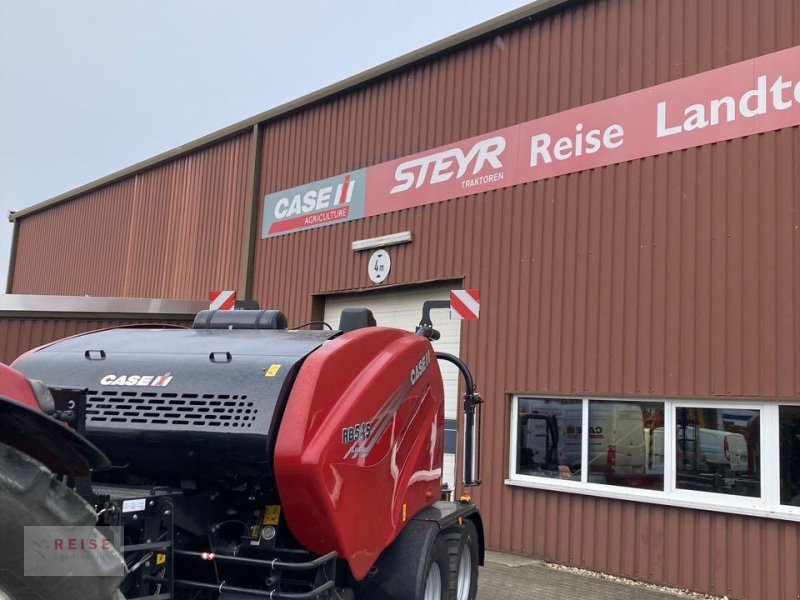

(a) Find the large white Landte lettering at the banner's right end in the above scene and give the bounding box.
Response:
[656,75,800,138]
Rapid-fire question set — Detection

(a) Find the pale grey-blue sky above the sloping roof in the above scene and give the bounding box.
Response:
[0,0,526,291]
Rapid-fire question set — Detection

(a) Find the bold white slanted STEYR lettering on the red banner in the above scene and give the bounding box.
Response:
[389,135,506,194]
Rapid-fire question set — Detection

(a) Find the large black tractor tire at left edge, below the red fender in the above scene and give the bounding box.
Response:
[0,444,124,600]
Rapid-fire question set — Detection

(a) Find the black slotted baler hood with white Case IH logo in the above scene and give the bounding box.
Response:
[14,328,338,479]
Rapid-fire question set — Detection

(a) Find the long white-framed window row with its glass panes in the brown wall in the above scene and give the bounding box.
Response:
[506,395,800,520]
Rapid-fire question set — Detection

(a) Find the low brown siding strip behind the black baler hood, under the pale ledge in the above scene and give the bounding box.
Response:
[0,315,192,365]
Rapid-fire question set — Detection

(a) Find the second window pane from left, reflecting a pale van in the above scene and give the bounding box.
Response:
[589,400,664,490]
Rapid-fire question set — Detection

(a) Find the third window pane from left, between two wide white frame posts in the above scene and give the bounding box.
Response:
[675,407,761,497]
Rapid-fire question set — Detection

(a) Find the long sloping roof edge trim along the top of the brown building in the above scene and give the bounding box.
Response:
[8,0,577,223]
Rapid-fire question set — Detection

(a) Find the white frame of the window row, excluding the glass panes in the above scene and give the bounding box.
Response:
[505,393,800,521]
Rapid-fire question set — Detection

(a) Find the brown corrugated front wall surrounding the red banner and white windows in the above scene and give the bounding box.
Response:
[254,0,800,599]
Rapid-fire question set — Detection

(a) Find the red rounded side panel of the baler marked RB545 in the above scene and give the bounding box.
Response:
[274,327,444,580]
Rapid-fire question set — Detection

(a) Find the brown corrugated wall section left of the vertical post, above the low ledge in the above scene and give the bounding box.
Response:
[13,134,250,300]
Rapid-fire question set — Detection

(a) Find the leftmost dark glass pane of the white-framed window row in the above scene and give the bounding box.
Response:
[517,398,583,481]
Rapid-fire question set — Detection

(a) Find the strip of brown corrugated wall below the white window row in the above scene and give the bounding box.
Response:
[510,490,800,600]
